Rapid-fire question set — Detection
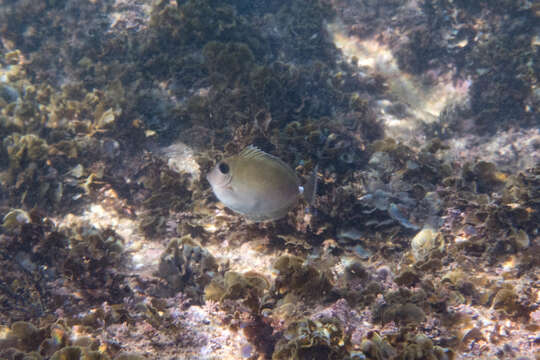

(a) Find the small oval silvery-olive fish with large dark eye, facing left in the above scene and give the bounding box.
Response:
[206,145,316,222]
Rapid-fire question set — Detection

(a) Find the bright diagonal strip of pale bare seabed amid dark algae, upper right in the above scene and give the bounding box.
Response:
[327,22,470,136]
